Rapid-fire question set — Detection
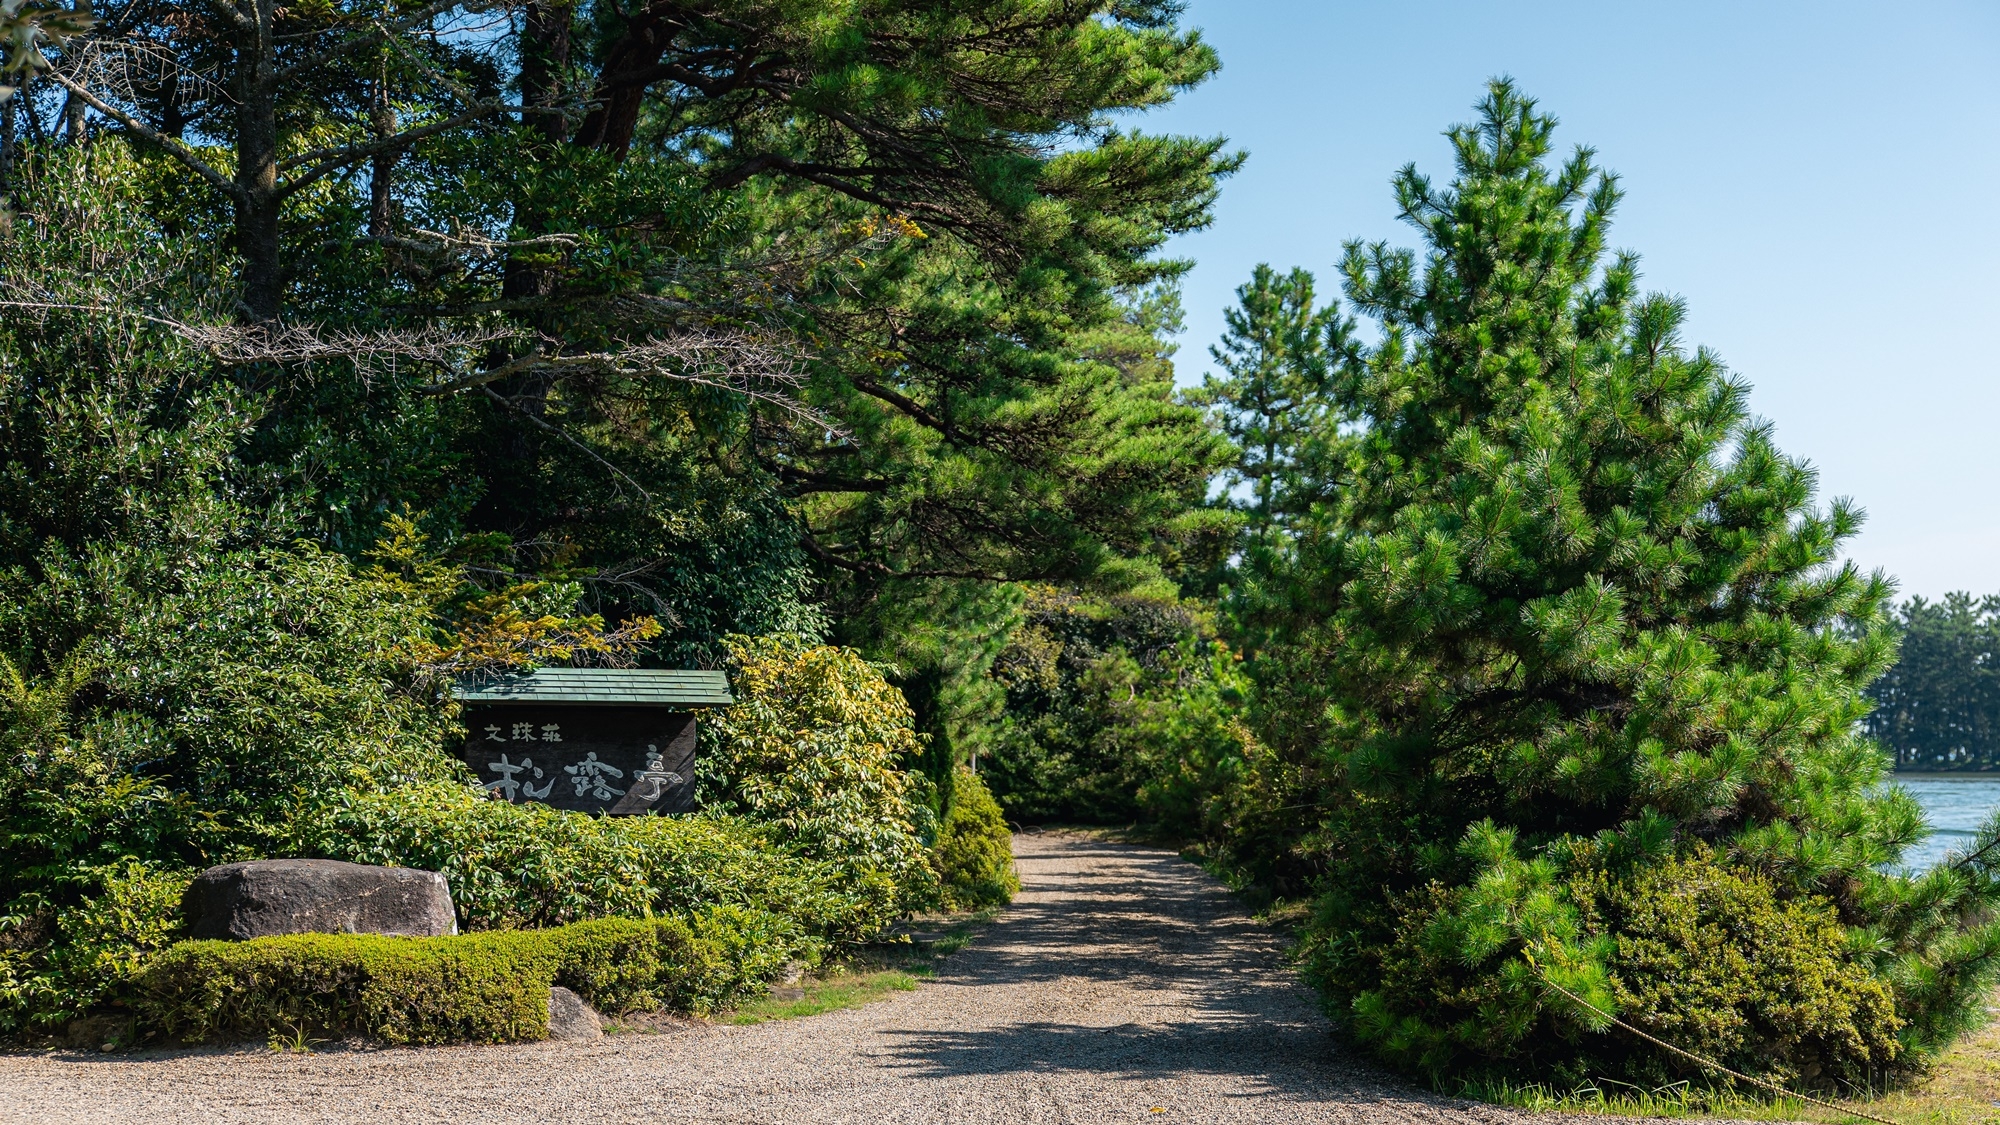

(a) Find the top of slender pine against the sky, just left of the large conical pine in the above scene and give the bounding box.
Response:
[1200,262,1354,530]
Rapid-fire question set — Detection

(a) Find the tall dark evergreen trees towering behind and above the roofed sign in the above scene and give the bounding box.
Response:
[0,0,1236,661]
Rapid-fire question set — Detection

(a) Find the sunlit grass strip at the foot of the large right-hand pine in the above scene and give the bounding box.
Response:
[1458,1008,2000,1125]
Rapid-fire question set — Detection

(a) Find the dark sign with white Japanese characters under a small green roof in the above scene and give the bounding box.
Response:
[460,669,730,817]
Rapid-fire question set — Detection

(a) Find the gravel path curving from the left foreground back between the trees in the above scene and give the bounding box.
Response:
[0,833,1602,1125]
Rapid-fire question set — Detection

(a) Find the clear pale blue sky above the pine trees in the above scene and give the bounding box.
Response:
[1136,0,2000,597]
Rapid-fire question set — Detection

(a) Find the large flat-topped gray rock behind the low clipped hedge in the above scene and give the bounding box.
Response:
[180,859,458,941]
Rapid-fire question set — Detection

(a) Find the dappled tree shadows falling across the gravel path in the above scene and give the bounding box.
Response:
[884,837,1466,1109]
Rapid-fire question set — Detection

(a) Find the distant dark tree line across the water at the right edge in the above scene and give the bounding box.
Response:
[1866,593,2000,769]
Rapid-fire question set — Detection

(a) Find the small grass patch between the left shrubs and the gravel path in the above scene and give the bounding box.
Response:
[716,909,1000,1025]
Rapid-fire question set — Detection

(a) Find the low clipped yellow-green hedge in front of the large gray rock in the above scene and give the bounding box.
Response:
[132,907,816,1045]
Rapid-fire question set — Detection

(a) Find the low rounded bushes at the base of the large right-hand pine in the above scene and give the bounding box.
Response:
[1352,845,1902,1089]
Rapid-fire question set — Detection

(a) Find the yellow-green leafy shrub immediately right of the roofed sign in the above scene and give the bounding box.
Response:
[700,637,934,907]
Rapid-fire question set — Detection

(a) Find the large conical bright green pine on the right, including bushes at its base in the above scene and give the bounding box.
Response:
[1266,82,2000,1085]
